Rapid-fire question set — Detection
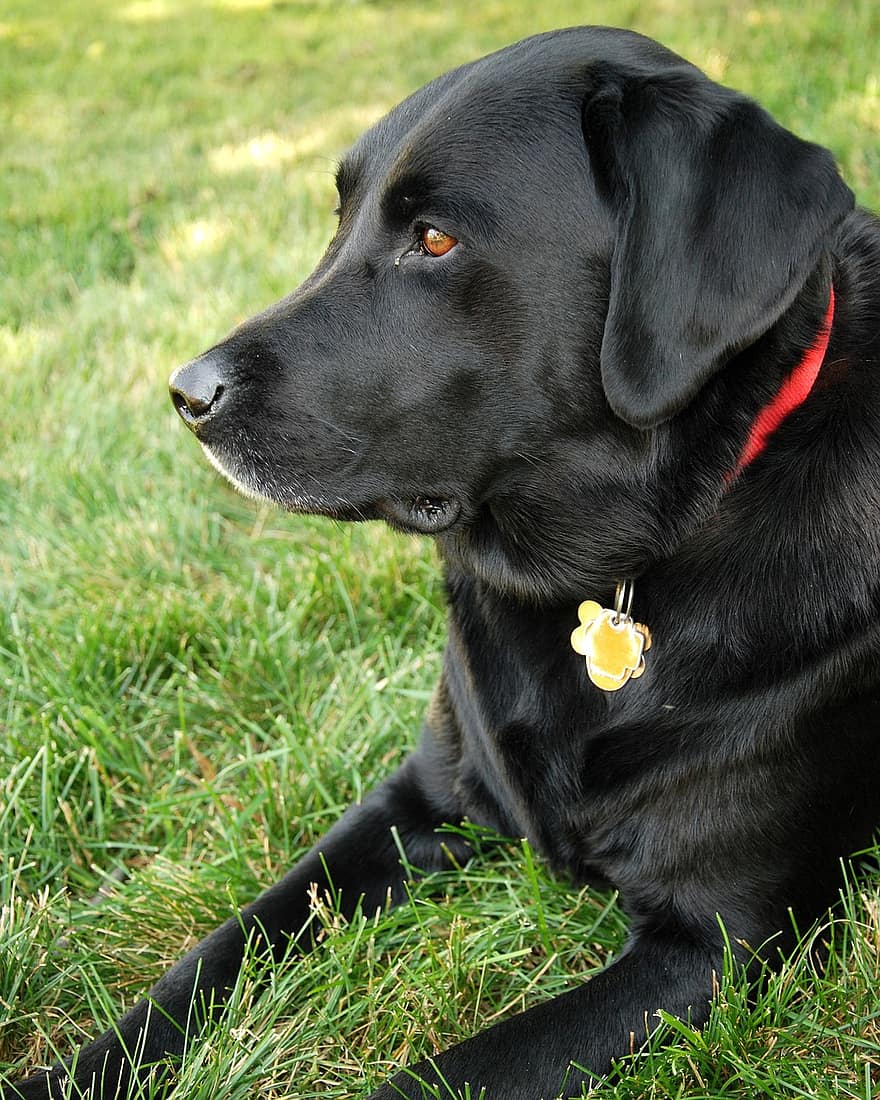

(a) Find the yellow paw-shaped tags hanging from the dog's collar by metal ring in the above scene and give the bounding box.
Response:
[571,585,651,691]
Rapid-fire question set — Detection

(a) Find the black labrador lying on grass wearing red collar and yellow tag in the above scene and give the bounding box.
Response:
[3,28,880,1100]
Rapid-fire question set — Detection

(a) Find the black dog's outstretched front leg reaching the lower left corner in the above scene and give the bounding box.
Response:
[0,736,468,1100]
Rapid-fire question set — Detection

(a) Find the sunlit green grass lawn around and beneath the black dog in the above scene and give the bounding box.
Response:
[0,0,880,1100]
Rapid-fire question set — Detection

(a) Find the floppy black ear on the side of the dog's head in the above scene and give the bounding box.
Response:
[583,63,854,427]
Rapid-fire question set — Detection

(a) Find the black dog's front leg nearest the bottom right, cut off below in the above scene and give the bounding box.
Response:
[369,932,723,1100]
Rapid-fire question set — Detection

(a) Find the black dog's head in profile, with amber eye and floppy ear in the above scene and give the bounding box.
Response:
[172,28,853,598]
